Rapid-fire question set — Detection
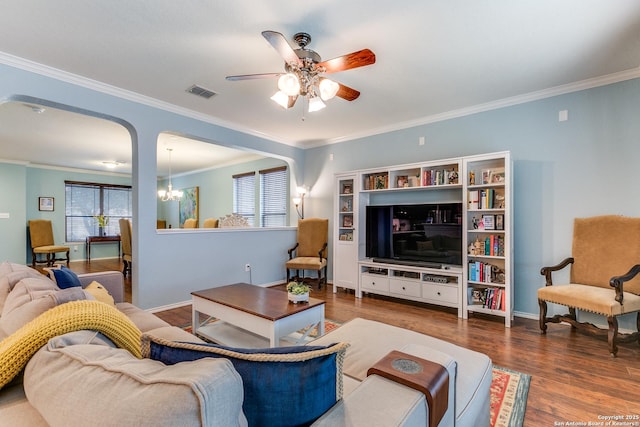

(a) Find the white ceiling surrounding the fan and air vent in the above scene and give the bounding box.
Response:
[0,0,640,174]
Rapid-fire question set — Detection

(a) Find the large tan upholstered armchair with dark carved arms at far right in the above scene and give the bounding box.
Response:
[538,215,640,356]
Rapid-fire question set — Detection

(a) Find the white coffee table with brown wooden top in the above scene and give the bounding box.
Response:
[191,283,324,348]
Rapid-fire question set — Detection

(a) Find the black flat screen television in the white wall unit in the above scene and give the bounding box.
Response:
[365,202,462,268]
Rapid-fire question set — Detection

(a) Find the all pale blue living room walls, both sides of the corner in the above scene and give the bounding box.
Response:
[0,58,640,327]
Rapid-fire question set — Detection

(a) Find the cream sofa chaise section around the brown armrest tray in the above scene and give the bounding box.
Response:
[313,318,492,427]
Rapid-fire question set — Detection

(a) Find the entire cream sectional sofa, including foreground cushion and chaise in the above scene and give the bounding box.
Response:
[0,263,491,427]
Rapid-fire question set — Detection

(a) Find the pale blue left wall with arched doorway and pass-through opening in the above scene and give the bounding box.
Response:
[0,65,304,308]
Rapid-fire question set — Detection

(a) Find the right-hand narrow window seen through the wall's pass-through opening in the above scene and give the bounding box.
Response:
[260,167,287,227]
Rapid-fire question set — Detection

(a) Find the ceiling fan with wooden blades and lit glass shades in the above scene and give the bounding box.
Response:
[227,31,376,112]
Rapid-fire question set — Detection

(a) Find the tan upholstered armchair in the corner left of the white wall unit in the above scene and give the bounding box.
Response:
[285,218,329,287]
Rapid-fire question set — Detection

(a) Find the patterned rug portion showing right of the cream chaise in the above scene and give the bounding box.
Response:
[491,365,531,427]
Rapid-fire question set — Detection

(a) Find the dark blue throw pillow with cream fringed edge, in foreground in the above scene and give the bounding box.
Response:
[142,335,349,427]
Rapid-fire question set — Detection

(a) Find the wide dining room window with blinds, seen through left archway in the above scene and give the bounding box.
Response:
[64,181,133,242]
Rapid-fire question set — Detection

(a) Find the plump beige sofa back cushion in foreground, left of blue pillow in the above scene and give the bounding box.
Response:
[24,331,246,427]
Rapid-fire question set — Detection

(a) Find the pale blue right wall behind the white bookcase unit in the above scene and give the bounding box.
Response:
[305,79,640,328]
